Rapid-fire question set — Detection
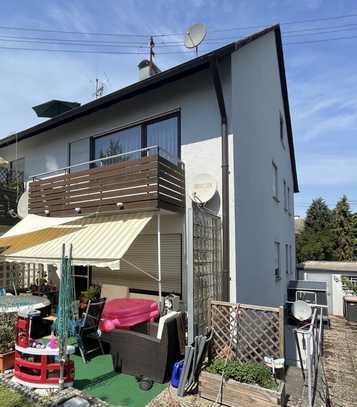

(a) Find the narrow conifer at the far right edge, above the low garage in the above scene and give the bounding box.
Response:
[334,195,354,261]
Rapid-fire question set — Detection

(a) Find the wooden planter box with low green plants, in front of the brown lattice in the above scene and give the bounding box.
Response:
[199,358,285,407]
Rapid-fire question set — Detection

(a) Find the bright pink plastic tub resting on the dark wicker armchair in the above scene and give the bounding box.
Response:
[101,298,160,332]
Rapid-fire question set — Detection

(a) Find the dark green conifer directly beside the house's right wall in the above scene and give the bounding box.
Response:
[296,198,334,262]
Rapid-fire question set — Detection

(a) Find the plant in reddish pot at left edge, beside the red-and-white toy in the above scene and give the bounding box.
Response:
[0,312,17,373]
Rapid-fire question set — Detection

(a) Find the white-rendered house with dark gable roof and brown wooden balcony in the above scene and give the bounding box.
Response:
[0,26,298,334]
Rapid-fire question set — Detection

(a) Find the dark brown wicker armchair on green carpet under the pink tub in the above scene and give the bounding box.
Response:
[110,314,182,390]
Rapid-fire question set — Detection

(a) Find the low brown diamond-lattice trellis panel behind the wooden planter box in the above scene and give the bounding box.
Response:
[209,301,284,362]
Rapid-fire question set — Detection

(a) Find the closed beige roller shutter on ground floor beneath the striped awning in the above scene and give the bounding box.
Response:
[92,234,182,295]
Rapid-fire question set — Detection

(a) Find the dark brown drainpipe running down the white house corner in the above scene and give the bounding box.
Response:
[210,58,230,301]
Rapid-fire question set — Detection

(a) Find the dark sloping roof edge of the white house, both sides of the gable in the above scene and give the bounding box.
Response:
[0,25,299,192]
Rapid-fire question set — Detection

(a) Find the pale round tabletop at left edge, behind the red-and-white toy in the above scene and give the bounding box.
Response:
[0,295,51,313]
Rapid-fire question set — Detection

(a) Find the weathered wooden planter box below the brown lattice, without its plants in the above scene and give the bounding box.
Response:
[199,372,285,407]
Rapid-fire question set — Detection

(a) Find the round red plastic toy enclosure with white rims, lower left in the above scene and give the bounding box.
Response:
[13,345,75,389]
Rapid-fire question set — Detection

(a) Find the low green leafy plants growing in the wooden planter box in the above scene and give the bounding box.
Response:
[206,358,277,389]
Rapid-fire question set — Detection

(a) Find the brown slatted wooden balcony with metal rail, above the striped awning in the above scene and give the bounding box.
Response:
[29,147,185,217]
